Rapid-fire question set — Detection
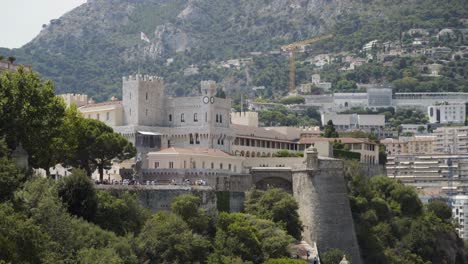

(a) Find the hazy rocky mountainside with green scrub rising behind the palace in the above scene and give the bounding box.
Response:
[0,0,468,100]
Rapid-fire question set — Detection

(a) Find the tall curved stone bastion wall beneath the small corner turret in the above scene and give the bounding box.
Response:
[292,160,362,264]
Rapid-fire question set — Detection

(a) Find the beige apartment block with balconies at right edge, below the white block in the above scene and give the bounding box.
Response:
[432,126,468,154]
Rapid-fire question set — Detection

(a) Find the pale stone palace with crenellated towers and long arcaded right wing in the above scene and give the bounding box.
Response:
[62,75,378,169]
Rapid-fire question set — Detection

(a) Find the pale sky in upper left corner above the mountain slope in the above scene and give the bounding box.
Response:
[0,0,86,49]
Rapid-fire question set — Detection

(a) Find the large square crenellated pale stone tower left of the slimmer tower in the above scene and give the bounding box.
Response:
[122,75,165,126]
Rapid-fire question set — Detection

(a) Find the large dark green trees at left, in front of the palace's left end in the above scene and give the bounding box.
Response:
[0,68,136,180]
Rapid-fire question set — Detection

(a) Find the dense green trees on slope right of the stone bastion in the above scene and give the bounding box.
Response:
[350,172,466,264]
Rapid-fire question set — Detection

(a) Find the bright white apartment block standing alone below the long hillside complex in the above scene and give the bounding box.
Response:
[427,103,466,124]
